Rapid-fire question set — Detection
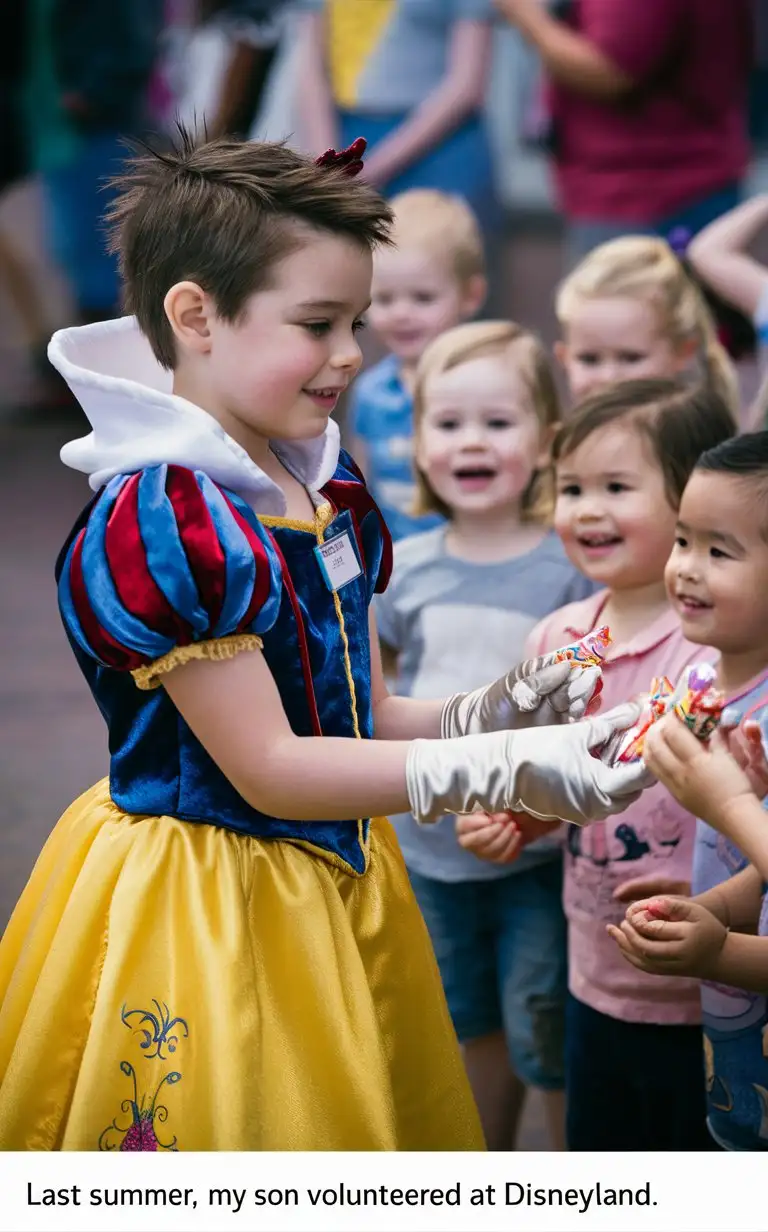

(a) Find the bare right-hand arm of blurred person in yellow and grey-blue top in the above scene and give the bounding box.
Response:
[365,20,491,185]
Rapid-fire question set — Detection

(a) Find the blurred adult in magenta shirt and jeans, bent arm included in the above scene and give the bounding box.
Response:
[496,0,754,261]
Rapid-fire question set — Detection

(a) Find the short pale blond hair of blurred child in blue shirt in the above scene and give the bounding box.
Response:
[391,188,486,282]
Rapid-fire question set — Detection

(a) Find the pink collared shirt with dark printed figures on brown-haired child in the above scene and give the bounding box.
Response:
[526,590,715,1025]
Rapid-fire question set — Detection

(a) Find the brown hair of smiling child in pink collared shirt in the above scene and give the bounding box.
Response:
[552,379,737,509]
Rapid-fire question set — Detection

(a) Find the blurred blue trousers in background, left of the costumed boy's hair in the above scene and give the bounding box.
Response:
[43,133,126,317]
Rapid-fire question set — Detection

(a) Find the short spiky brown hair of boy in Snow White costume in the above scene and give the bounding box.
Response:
[108,128,392,368]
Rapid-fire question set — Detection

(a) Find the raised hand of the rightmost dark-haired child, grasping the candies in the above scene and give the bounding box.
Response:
[642,715,753,830]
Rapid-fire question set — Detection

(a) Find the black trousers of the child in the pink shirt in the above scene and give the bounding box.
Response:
[566,995,717,1151]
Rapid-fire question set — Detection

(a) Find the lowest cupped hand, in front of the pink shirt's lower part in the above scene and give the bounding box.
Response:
[607,896,727,978]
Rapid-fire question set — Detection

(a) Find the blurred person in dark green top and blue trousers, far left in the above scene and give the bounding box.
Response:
[26,0,164,323]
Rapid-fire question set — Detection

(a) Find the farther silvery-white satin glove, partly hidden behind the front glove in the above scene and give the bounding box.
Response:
[440,654,602,740]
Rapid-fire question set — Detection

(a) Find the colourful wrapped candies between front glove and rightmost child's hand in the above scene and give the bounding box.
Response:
[600,663,725,761]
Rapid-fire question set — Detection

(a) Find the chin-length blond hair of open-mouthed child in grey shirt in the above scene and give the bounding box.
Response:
[413,320,560,521]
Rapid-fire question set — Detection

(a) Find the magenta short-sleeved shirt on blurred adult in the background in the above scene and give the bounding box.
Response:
[551,0,753,224]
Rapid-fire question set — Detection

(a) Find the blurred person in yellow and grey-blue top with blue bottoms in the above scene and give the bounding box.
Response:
[298,0,496,227]
